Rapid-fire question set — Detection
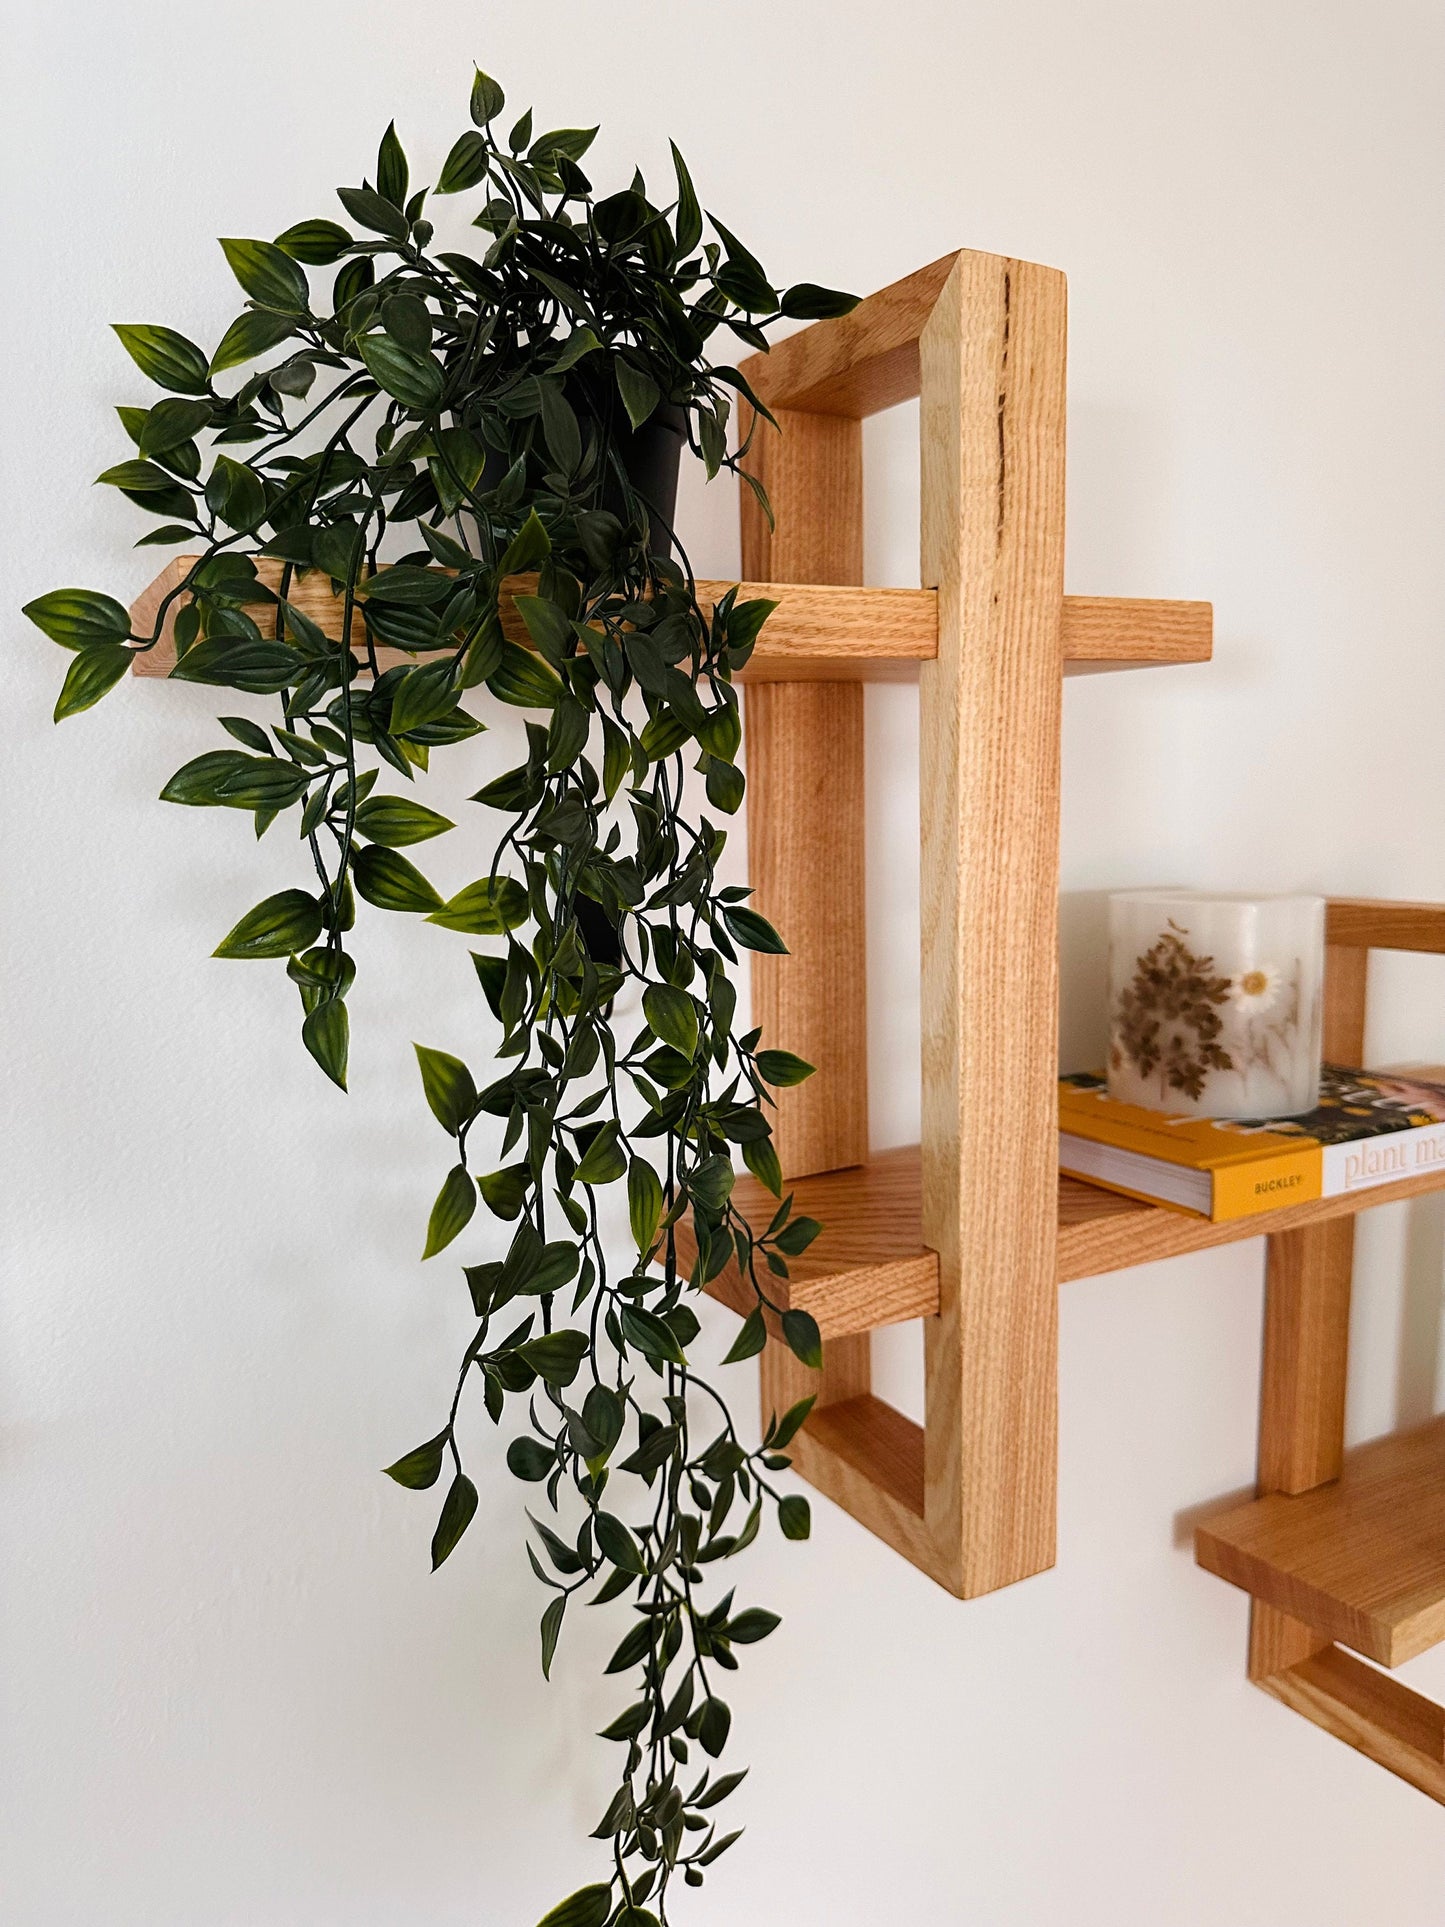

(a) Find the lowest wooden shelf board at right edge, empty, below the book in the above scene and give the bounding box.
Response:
[1195,1416,1445,1667]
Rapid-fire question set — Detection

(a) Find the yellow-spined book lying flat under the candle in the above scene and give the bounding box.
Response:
[1060,1064,1445,1222]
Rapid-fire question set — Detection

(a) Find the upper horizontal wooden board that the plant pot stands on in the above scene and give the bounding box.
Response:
[131,555,1212,682]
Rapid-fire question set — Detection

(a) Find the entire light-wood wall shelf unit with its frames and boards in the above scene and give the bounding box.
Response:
[133,252,1445,1800]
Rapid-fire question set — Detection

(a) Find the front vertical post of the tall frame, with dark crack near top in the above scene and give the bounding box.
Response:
[919,252,1065,1597]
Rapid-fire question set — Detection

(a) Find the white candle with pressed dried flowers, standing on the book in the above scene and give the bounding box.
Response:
[1108,890,1324,1118]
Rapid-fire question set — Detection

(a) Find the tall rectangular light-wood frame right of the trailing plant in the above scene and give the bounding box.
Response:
[735,251,1210,1597]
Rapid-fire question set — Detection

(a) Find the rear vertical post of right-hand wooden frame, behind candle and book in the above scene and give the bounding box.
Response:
[1248,944,1370,1678]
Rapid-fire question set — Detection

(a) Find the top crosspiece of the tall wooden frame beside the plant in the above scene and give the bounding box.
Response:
[742,254,958,420]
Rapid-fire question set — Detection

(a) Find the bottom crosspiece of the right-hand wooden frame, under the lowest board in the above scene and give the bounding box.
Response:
[1256,1646,1445,1804]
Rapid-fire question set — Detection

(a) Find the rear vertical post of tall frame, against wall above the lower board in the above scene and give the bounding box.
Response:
[742,410,869,1179]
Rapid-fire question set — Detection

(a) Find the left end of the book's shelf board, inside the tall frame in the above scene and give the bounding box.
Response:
[707,1145,938,1337]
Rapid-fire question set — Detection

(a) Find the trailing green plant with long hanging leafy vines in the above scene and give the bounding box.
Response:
[27,73,854,1927]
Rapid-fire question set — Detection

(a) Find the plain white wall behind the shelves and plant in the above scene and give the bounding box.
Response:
[0,0,1445,1927]
